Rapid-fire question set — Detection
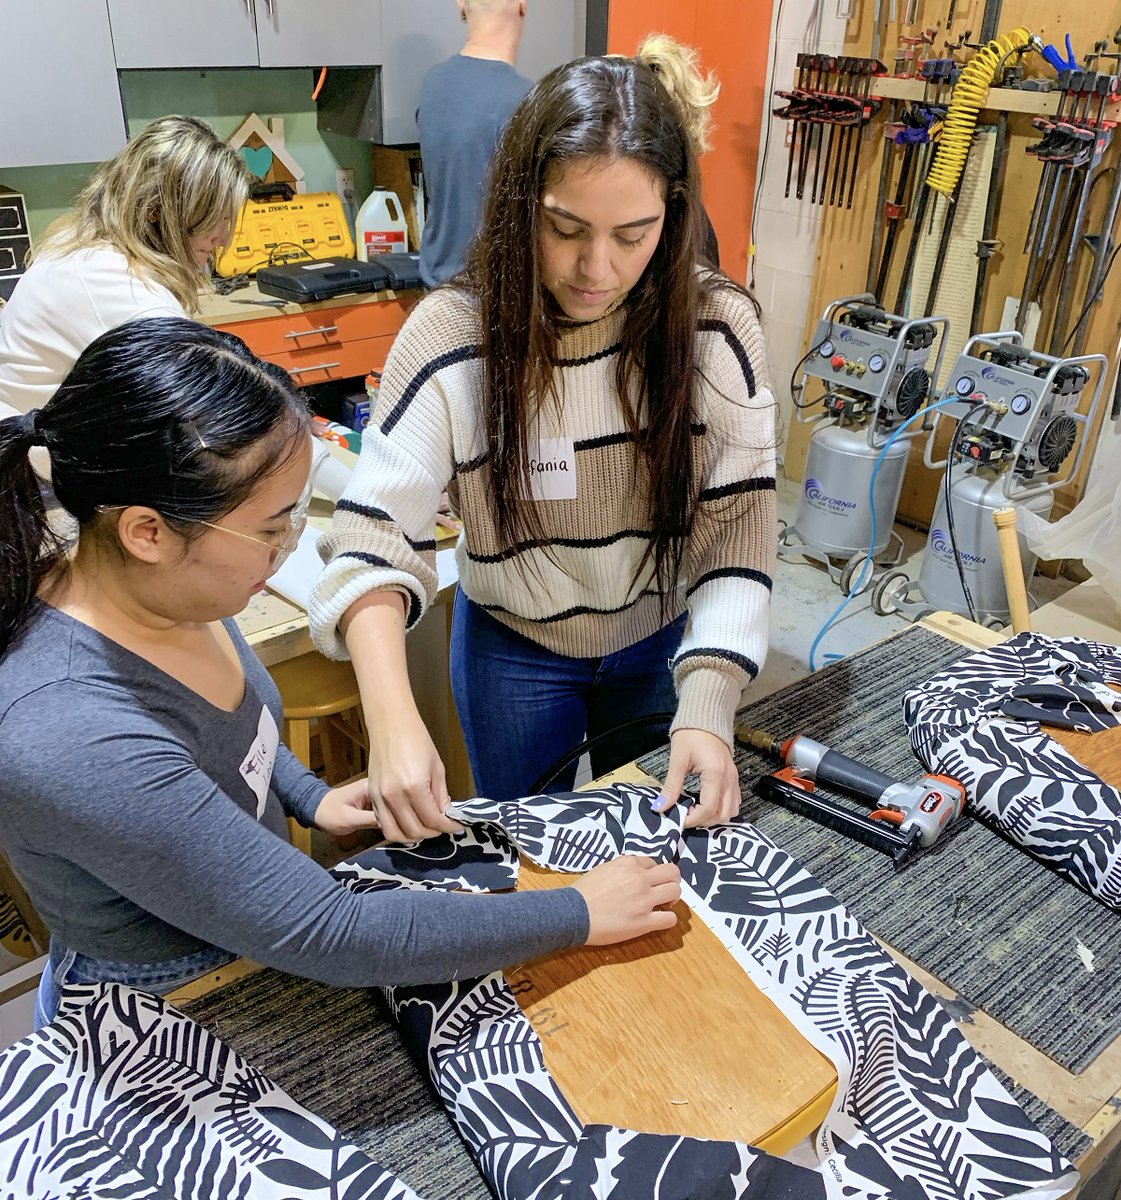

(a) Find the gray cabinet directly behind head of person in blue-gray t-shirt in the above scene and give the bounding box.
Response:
[379,0,586,145]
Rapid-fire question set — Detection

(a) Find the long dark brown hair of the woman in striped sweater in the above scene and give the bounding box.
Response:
[457,58,733,602]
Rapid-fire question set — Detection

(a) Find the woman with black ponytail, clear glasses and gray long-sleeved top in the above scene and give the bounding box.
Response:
[0,318,679,1024]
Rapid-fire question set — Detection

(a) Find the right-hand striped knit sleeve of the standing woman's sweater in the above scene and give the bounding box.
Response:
[672,289,778,745]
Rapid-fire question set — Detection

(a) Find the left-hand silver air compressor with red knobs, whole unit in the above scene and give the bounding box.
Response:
[779,295,949,593]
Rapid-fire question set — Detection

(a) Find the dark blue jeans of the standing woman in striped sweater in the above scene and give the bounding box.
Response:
[451,590,685,800]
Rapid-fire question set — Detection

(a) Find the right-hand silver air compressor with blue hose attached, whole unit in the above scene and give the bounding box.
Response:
[871,331,1107,626]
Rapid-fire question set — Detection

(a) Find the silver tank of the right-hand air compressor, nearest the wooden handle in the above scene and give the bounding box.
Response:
[918,474,1055,625]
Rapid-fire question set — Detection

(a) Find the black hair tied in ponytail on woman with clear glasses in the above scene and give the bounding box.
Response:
[0,317,308,653]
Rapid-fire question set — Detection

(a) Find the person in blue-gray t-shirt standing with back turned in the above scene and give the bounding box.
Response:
[416,0,532,288]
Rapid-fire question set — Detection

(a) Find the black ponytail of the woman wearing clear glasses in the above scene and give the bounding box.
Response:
[0,409,66,654]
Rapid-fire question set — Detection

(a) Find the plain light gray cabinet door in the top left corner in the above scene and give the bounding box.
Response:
[0,0,126,168]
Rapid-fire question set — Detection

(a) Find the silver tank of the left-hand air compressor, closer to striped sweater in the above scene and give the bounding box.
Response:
[795,422,916,556]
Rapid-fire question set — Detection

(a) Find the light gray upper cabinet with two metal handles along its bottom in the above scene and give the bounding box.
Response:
[108,0,381,68]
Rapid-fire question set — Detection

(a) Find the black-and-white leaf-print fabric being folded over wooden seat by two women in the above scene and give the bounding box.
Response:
[338,785,1077,1200]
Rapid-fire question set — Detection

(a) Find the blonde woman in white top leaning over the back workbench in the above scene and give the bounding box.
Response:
[0,116,250,422]
